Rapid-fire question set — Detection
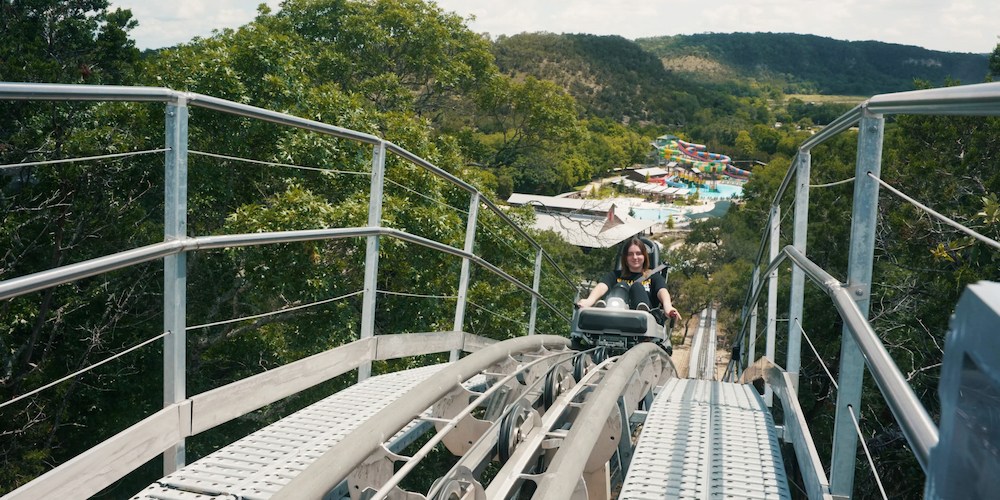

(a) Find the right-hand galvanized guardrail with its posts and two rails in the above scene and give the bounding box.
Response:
[727,83,1000,496]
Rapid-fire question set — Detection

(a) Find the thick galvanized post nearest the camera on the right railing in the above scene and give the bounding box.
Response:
[830,109,885,497]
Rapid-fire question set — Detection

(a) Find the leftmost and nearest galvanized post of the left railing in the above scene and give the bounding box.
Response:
[163,97,188,474]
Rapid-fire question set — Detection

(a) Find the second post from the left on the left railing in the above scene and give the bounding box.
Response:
[358,141,385,382]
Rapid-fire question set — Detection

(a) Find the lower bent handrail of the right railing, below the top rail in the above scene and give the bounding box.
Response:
[737,245,938,472]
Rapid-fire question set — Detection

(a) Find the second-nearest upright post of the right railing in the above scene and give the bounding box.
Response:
[785,151,812,394]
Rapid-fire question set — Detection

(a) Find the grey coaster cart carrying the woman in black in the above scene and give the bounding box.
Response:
[570,238,674,357]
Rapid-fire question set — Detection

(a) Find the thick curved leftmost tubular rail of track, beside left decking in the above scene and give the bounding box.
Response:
[271,335,569,500]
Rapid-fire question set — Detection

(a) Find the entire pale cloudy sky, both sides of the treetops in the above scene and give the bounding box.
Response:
[111,0,1000,53]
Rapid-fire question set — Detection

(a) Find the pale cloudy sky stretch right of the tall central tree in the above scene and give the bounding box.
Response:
[437,0,1000,53]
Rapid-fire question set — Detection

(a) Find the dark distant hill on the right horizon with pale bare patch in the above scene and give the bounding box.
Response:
[636,33,989,96]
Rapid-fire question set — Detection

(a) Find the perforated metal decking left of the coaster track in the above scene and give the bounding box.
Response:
[132,364,446,500]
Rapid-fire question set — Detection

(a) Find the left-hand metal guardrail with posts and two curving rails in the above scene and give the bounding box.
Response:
[0,82,577,493]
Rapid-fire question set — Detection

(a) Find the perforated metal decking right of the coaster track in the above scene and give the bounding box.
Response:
[619,379,790,499]
